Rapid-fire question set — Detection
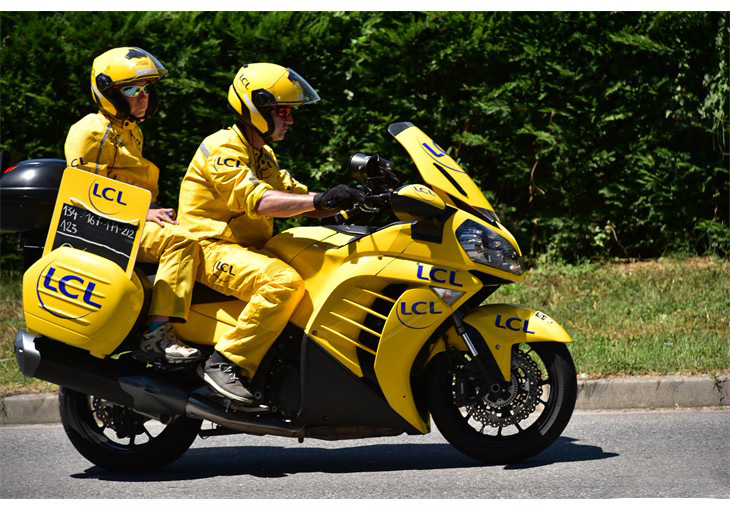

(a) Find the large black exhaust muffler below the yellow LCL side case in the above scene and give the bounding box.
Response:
[15,329,189,417]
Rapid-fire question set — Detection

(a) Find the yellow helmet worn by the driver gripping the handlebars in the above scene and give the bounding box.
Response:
[228,64,319,139]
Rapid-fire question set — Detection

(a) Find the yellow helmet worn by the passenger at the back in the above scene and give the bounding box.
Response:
[91,46,167,120]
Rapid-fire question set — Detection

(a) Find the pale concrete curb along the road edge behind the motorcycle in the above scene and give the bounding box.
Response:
[0,376,730,425]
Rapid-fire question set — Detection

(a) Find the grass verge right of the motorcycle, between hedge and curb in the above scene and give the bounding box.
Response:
[487,258,730,378]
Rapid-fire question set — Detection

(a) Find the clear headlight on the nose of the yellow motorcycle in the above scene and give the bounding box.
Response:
[456,220,523,275]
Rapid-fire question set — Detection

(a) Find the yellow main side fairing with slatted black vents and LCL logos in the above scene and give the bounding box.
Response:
[258,207,521,433]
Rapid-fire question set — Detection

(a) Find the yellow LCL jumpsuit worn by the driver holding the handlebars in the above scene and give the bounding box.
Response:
[179,126,307,377]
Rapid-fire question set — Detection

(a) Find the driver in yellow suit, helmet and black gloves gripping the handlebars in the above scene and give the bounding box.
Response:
[179,64,364,404]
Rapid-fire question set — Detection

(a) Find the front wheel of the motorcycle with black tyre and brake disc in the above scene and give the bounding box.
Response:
[428,342,578,464]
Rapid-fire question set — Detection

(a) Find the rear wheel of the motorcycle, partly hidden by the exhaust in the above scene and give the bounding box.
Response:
[59,388,202,471]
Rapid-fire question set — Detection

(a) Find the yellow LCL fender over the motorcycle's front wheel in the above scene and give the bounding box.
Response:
[429,304,573,381]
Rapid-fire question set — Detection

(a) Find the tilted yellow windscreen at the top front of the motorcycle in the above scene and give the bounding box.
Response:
[388,122,494,211]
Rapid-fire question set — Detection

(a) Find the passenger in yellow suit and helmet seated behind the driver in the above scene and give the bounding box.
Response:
[65,47,202,363]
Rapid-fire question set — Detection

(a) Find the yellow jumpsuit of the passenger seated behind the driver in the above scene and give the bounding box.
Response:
[64,111,202,322]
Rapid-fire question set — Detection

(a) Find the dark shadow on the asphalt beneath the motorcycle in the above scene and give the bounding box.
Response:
[71,437,617,482]
